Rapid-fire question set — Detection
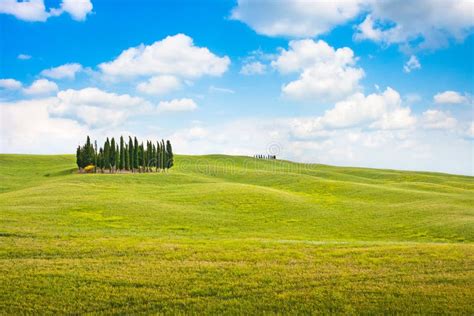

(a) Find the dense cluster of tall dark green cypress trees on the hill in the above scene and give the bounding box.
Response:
[76,136,174,173]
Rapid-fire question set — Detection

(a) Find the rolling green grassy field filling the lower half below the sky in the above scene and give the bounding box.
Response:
[0,155,474,314]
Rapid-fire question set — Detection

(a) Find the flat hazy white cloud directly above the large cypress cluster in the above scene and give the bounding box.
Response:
[49,88,153,128]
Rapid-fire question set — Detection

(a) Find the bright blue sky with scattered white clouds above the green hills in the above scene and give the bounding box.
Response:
[0,0,474,175]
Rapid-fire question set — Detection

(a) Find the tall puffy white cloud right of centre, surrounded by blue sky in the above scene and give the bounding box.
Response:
[272,39,364,102]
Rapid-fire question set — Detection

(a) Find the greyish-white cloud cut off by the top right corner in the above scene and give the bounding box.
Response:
[355,0,474,49]
